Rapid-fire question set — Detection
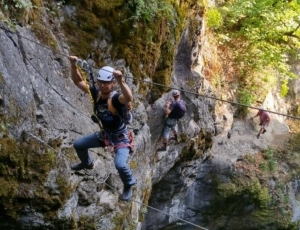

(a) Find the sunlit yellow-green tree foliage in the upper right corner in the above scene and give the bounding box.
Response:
[214,0,300,96]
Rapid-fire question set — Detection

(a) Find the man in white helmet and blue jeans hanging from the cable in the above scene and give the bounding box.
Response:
[69,56,136,201]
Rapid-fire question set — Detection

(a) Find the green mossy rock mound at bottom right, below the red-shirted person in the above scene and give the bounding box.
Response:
[206,150,298,230]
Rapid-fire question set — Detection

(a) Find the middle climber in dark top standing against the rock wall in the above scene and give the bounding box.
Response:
[157,89,186,151]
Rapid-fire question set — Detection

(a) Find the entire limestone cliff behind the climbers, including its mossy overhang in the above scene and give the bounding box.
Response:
[0,0,299,229]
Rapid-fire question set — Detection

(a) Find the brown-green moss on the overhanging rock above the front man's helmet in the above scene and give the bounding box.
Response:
[63,1,192,100]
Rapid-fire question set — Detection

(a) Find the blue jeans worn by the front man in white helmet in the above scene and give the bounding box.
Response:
[73,129,136,187]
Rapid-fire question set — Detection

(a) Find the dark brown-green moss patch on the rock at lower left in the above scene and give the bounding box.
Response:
[0,129,56,218]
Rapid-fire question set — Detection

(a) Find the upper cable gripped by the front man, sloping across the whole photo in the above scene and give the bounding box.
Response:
[0,27,300,120]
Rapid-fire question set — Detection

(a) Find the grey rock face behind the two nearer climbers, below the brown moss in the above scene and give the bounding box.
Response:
[0,12,214,229]
